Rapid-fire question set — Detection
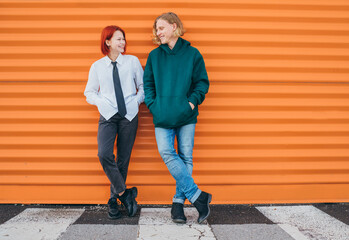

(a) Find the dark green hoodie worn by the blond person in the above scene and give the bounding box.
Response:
[143,38,209,128]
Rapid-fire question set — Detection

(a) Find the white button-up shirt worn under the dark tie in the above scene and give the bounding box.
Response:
[84,54,144,121]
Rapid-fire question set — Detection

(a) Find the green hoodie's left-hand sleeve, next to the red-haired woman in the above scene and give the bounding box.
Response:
[143,54,156,108]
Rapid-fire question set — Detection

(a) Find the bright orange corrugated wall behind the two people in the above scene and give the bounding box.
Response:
[0,0,349,204]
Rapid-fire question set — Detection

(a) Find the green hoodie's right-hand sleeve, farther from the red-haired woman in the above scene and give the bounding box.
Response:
[188,51,210,106]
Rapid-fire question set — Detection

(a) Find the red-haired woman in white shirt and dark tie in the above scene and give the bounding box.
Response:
[84,26,144,219]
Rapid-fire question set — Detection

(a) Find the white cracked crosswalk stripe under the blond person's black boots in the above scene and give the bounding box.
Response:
[138,208,216,240]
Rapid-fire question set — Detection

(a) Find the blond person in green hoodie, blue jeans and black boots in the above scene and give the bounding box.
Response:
[143,12,212,223]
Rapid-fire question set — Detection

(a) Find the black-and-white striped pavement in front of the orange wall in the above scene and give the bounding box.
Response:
[0,203,349,240]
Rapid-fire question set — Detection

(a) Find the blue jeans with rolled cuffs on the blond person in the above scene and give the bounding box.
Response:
[155,124,201,203]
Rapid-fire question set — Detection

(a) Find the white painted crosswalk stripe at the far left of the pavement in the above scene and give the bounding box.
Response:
[0,208,84,240]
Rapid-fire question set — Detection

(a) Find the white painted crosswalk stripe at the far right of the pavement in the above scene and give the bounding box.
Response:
[257,205,349,240]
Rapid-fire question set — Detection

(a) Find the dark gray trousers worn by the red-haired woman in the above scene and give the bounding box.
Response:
[97,114,138,198]
